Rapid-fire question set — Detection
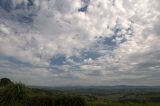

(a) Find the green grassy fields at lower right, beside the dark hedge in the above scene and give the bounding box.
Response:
[87,92,160,106]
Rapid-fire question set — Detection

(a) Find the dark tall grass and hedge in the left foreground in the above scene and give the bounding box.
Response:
[0,80,86,106]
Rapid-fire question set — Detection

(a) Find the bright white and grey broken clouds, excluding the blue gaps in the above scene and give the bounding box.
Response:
[0,0,160,84]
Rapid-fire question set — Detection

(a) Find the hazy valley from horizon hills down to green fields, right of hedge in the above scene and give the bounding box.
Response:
[31,85,160,106]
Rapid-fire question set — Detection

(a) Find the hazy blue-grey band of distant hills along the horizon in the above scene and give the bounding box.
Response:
[30,85,160,94]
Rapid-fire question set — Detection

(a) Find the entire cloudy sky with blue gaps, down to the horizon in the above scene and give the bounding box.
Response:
[0,0,160,86]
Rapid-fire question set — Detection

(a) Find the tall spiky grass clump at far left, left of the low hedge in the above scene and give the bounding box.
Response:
[0,83,28,106]
